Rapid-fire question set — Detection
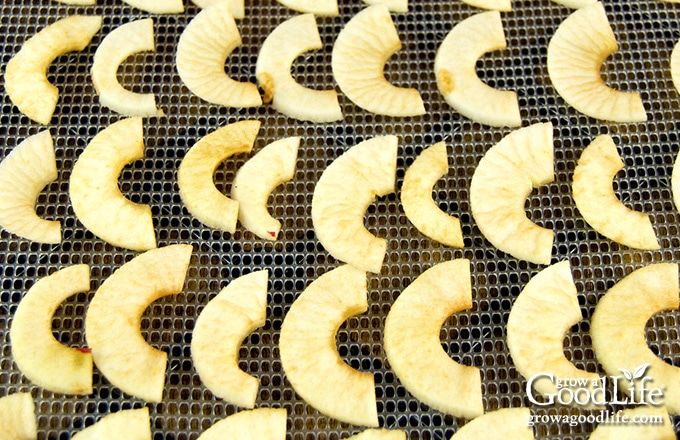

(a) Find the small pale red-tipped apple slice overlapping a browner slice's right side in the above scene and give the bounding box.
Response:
[231,137,300,240]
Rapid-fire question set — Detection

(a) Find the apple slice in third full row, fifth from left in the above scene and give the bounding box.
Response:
[384,259,484,419]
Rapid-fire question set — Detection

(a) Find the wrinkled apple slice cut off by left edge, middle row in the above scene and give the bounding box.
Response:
[0,131,61,244]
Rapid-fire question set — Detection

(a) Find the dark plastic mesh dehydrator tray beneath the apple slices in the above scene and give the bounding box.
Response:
[0,0,680,440]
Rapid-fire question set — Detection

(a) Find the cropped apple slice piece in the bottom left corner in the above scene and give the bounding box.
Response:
[0,393,38,440]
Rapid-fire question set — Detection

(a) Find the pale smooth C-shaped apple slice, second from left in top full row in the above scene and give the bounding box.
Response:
[90,18,164,116]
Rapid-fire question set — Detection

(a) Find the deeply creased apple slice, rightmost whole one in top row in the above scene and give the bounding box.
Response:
[547,2,647,122]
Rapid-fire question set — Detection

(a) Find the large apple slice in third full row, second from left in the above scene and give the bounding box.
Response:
[85,244,192,402]
